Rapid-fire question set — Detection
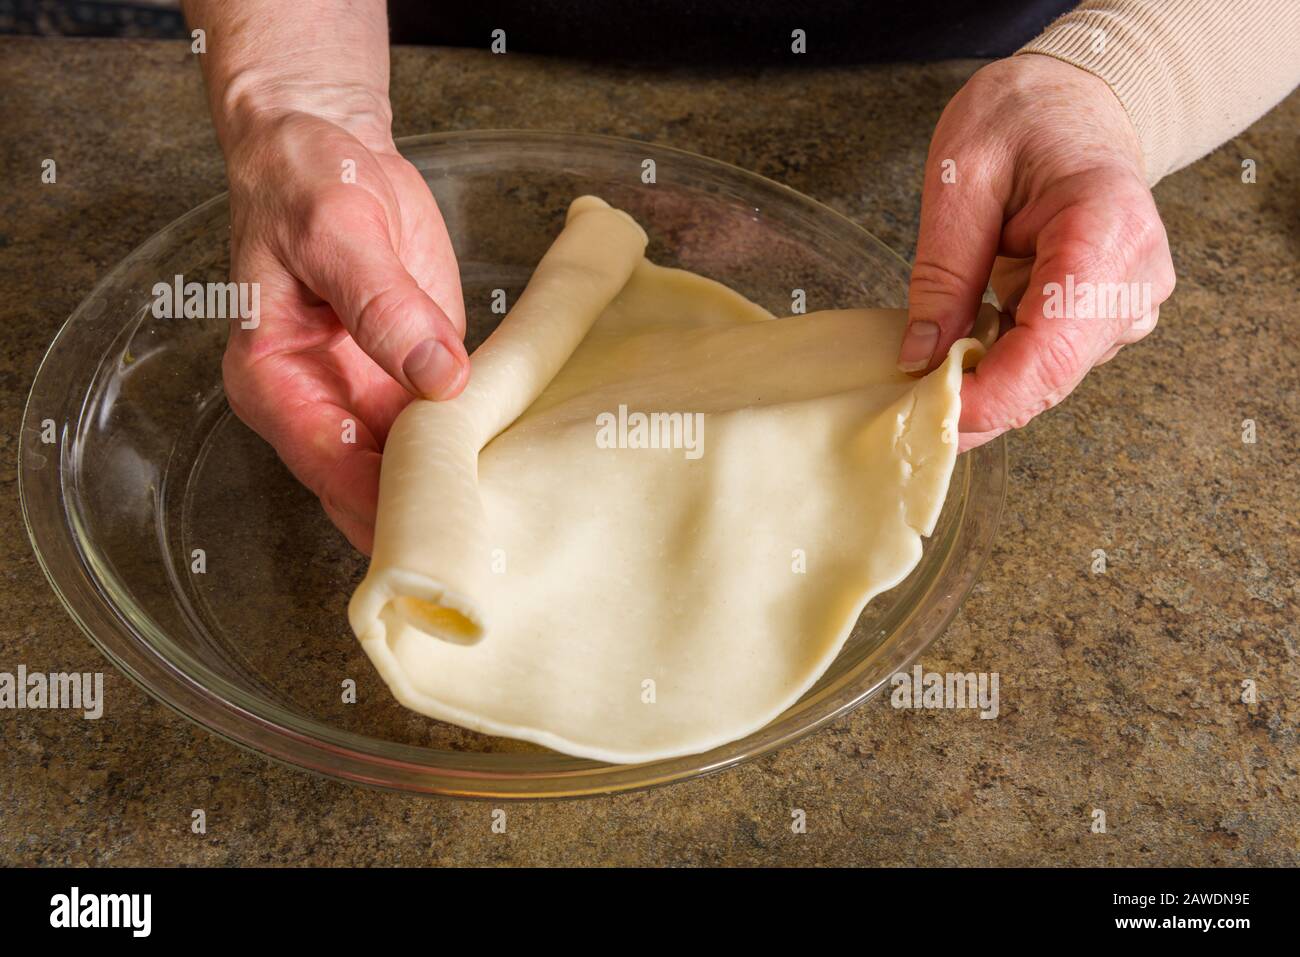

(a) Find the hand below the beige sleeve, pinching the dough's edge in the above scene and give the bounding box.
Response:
[898,55,1174,451]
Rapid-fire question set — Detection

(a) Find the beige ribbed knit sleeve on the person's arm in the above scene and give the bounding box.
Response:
[1018,0,1300,183]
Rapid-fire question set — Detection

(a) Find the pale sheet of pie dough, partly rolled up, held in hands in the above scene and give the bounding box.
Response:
[348,196,983,762]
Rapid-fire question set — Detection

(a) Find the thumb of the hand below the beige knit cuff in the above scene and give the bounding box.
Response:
[898,148,1002,373]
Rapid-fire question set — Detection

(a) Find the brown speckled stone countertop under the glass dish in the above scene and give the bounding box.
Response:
[0,38,1300,865]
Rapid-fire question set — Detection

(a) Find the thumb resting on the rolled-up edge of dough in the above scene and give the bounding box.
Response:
[299,209,469,399]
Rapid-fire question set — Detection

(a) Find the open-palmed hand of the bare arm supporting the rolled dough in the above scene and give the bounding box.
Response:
[222,112,469,553]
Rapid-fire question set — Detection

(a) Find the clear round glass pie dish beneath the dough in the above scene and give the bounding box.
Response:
[20,131,1006,798]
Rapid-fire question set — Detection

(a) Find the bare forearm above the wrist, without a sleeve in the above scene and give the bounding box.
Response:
[182,0,393,155]
